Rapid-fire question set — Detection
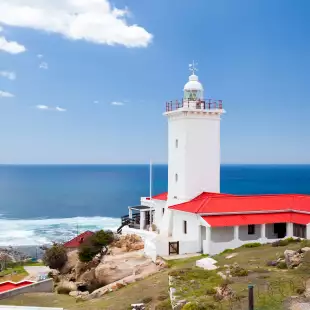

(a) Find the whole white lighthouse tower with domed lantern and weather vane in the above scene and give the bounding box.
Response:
[164,62,224,206]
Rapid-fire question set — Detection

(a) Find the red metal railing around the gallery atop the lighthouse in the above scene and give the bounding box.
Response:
[166,99,223,112]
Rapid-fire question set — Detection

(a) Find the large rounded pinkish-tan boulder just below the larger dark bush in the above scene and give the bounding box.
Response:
[95,262,133,285]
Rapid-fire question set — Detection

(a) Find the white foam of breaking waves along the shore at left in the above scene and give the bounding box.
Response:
[0,217,120,246]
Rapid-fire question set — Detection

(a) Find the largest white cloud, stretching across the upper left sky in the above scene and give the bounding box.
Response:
[0,0,152,47]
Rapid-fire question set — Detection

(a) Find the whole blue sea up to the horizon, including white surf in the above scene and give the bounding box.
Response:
[0,165,310,246]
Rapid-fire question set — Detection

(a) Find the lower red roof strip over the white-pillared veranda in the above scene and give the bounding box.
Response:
[202,212,310,227]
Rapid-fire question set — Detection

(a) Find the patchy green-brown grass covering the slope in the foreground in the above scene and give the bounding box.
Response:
[1,243,310,310]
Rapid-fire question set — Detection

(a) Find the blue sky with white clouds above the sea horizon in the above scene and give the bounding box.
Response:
[0,0,310,164]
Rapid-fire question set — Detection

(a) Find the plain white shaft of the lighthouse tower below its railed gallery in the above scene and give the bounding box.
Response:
[167,111,220,205]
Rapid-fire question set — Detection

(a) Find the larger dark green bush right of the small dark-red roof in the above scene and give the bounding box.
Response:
[79,230,114,262]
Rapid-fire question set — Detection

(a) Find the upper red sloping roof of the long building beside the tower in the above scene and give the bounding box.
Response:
[169,193,310,214]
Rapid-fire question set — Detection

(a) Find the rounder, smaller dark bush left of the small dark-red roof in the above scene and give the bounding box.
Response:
[43,243,68,270]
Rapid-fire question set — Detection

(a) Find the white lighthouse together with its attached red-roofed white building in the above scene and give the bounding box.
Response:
[122,65,310,259]
